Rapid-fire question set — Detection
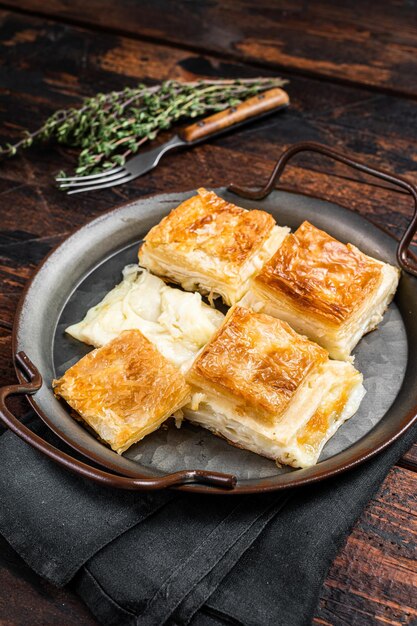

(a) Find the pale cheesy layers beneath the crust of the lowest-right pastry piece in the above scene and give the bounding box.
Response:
[183,361,365,467]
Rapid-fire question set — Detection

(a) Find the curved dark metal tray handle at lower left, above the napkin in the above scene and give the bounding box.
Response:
[0,352,236,491]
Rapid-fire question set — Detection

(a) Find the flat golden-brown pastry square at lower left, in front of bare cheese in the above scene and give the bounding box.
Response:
[52,330,190,454]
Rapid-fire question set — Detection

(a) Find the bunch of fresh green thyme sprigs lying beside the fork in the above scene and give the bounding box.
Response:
[0,78,286,174]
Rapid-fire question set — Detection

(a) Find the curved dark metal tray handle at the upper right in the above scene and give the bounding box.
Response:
[228,142,417,277]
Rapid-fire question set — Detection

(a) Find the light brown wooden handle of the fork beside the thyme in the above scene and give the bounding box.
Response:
[179,87,290,143]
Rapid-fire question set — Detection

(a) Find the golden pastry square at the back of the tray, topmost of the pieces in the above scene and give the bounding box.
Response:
[139,189,289,304]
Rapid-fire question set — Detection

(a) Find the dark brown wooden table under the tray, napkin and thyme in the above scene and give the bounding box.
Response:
[0,0,417,626]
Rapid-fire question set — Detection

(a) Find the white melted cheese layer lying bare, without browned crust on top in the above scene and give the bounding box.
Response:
[66,265,224,371]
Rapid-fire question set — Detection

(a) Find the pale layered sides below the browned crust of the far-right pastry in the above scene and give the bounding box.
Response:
[240,263,399,359]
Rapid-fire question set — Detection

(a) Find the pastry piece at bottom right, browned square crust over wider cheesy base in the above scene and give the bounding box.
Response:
[183,306,365,467]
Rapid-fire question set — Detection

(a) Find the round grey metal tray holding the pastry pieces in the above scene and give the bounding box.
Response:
[14,189,417,494]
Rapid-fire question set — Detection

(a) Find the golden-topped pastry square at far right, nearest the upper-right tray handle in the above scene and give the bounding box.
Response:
[242,222,399,359]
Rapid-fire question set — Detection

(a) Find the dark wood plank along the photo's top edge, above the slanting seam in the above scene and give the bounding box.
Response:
[2,0,417,97]
